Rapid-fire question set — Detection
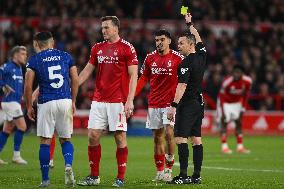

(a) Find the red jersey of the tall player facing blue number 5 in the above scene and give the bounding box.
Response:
[89,39,138,103]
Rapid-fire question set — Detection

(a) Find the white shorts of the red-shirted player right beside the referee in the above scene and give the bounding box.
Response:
[146,107,175,129]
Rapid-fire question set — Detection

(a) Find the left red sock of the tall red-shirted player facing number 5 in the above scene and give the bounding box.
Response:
[88,144,101,176]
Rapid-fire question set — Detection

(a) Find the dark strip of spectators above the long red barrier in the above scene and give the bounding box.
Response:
[0,0,284,23]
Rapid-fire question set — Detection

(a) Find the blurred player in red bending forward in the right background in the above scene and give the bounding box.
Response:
[217,65,252,154]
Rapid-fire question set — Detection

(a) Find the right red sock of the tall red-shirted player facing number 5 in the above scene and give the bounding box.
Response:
[116,147,128,180]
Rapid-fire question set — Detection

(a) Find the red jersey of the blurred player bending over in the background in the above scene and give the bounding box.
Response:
[219,75,252,105]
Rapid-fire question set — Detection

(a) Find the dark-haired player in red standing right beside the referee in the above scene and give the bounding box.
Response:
[136,29,183,182]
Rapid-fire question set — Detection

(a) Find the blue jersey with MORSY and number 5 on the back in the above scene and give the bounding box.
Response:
[27,49,74,104]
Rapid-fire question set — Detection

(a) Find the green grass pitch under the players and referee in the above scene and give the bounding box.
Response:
[0,135,284,189]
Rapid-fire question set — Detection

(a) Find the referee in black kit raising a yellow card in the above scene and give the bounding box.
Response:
[167,13,206,184]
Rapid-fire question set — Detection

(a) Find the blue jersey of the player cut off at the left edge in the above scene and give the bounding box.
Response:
[0,61,24,103]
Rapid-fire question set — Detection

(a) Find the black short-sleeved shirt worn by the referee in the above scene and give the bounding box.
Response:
[178,42,206,103]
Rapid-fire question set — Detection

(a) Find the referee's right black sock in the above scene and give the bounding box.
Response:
[192,144,203,178]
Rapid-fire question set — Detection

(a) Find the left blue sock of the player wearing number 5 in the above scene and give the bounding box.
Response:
[39,144,50,181]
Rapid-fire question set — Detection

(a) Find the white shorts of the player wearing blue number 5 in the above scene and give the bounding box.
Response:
[37,99,73,138]
